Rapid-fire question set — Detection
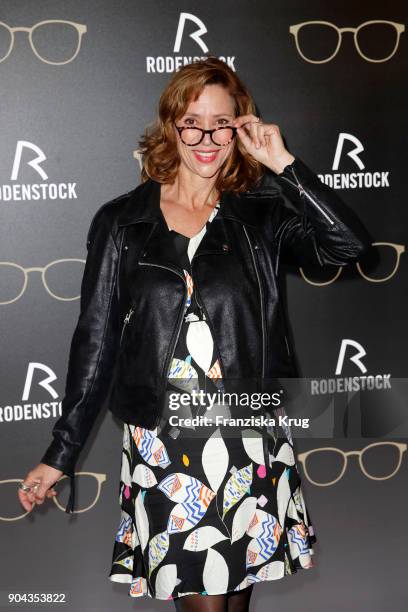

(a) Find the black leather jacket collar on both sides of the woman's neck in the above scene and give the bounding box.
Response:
[118,179,264,227]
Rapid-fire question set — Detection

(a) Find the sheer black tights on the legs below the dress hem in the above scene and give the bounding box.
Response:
[174,584,254,612]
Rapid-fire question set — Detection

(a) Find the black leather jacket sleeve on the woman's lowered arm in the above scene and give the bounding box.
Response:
[41,205,120,512]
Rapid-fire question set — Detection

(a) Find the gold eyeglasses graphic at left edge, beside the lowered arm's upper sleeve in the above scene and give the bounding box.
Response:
[0,258,85,306]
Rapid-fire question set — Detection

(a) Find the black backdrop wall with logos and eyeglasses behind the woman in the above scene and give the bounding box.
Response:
[0,0,408,612]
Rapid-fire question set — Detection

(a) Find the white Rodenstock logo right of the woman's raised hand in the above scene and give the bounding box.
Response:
[318,132,390,189]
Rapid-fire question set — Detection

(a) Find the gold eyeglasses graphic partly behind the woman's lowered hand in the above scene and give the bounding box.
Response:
[0,472,106,521]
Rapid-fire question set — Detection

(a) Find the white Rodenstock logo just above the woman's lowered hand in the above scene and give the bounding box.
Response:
[0,361,61,423]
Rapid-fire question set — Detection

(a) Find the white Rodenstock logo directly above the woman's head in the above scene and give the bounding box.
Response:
[146,13,235,73]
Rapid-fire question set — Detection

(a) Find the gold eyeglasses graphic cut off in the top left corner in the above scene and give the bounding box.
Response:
[0,19,86,66]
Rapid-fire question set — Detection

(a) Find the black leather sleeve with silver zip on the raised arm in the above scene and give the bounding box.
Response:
[268,157,372,266]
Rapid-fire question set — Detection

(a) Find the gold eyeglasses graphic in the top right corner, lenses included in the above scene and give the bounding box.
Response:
[289,19,405,64]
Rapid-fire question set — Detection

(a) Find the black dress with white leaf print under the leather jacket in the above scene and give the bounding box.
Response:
[109,204,316,600]
